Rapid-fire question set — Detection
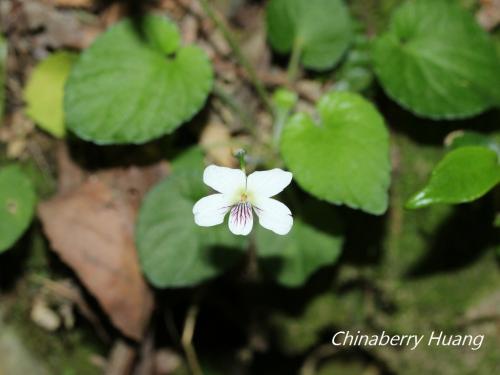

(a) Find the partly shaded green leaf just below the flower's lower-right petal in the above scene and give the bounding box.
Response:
[256,207,343,287]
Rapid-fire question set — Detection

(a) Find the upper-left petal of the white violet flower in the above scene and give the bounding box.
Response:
[203,165,246,195]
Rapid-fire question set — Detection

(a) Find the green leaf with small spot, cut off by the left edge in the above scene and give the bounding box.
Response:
[0,166,36,253]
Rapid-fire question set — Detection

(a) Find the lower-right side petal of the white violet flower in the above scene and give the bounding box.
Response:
[254,198,293,235]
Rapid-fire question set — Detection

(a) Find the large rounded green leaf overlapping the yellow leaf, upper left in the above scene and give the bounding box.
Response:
[64,16,213,144]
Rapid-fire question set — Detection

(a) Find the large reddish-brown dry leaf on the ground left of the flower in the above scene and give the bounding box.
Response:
[38,156,167,340]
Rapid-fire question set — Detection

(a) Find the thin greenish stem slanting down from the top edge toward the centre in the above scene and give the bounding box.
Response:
[198,0,272,113]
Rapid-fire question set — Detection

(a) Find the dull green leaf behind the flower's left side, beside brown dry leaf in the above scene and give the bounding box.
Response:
[136,151,245,288]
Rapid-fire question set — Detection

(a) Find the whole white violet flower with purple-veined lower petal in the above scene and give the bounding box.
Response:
[193,165,293,235]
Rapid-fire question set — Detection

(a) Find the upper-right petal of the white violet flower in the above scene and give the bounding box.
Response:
[247,168,293,199]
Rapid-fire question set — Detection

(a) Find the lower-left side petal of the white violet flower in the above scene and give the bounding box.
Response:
[193,194,231,227]
